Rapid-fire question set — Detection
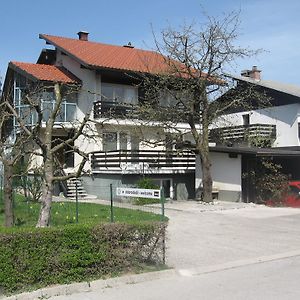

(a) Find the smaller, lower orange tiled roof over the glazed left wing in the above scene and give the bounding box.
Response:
[9,61,80,84]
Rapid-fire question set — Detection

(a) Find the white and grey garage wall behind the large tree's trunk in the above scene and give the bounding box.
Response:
[195,152,242,201]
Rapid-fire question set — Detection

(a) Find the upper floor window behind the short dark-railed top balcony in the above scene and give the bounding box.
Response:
[101,83,138,104]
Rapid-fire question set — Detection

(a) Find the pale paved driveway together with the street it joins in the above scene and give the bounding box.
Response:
[47,203,300,300]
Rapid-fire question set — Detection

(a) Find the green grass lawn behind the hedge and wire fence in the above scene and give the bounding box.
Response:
[0,195,165,227]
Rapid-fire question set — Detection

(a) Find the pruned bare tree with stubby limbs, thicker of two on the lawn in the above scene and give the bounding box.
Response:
[3,83,90,227]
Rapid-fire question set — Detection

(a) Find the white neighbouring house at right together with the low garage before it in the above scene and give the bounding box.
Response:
[196,67,300,201]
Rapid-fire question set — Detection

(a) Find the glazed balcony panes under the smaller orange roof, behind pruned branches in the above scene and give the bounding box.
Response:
[15,100,77,126]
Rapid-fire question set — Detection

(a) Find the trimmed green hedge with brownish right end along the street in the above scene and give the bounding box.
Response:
[0,222,166,294]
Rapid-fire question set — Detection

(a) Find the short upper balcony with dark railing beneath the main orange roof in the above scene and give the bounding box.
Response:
[94,100,137,119]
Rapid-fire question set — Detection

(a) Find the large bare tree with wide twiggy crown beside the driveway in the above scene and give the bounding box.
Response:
[140,12,266,202]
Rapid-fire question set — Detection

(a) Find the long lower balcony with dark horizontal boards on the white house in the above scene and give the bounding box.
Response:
[91,150,195,174]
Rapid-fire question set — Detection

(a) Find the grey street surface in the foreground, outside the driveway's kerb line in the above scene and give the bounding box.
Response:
[51,256,300,300]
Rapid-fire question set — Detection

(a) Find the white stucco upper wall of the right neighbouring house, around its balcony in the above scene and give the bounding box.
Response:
[216,103,300,147]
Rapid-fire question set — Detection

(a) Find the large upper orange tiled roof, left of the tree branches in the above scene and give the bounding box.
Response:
[40,34,180,74]
